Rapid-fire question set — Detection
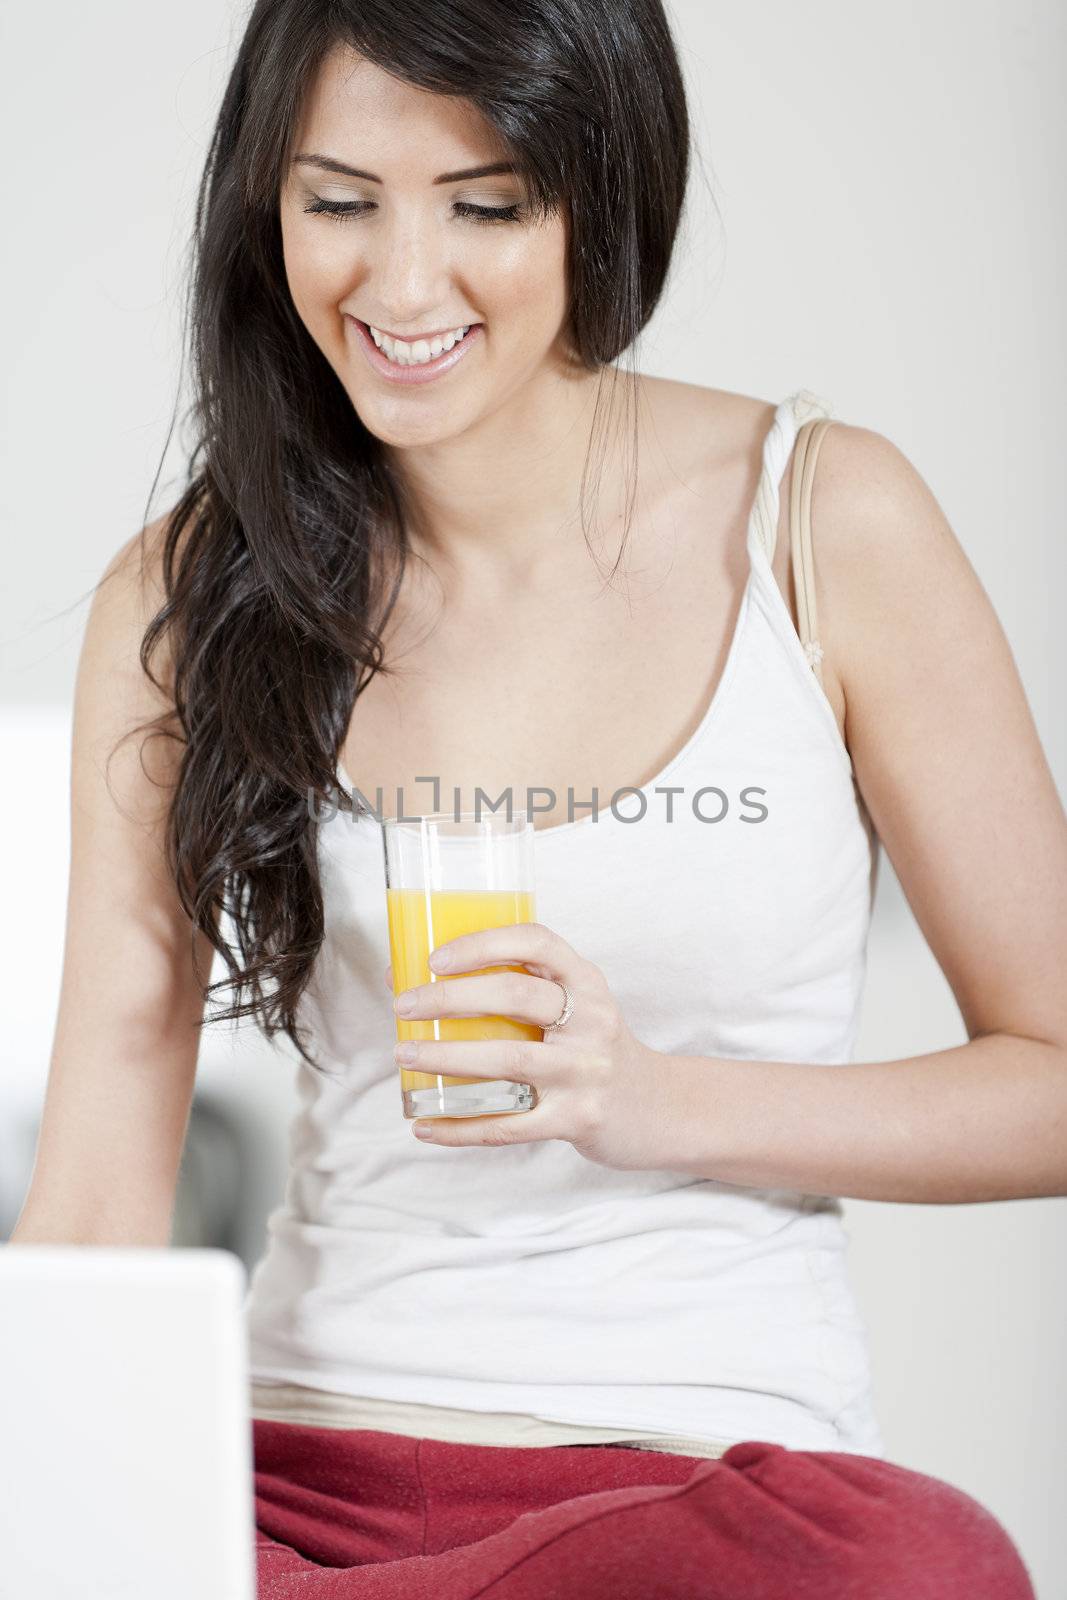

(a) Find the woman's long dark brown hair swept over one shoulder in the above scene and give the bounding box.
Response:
[131,0,689,1066]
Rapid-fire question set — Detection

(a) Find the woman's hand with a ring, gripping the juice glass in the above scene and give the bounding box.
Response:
[387,922,673,1168]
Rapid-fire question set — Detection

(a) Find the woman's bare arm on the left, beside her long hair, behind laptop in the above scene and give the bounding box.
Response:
[11,518,211,1245]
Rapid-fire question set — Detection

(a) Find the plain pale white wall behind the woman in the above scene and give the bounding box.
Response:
[0,0,1067,1600]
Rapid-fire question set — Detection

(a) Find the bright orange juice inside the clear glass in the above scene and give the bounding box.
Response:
[386,890,542,1091]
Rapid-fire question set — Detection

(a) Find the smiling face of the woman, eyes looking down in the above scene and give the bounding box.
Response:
[280,50,568,446]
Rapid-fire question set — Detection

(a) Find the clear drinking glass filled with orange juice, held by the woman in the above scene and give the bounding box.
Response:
[382,811,544,1118]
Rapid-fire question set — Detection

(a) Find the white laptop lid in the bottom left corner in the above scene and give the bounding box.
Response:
[0,1245,256,1600]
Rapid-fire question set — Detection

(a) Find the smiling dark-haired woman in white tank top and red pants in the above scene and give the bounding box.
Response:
[16,0,1067,1600]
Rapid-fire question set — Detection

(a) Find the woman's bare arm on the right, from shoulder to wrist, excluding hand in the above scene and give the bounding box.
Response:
[668,424,1067,1202]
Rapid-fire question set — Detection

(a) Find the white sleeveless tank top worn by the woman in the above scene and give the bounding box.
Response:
[246,390,883,1456]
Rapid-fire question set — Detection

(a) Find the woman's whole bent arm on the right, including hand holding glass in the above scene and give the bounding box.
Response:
[395,424,1067,1202]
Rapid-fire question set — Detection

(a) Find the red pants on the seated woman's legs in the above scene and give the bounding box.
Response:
[253,1419,1033,1600]
